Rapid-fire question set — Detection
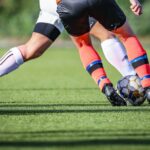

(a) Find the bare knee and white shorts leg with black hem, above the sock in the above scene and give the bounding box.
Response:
[19,0,64,61]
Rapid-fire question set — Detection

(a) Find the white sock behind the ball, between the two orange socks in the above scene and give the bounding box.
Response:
[101,38,136,76]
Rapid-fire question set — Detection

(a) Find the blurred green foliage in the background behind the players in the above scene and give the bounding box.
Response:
[0,0,150,37]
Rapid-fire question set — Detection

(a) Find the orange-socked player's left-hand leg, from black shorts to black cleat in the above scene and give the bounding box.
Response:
[57,0,126,106]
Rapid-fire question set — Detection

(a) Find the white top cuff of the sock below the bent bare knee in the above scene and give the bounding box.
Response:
[10,47,24,65]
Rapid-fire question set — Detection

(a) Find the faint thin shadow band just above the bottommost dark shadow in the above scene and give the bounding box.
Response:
[0,129,150,138]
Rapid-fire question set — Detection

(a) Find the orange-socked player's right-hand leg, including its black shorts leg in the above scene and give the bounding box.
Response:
[91,0,150,103]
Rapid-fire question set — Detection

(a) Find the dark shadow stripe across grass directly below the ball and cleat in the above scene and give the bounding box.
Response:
[0,104,150,115]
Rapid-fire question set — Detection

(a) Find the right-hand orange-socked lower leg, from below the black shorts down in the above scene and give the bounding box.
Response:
[115,22,150,102]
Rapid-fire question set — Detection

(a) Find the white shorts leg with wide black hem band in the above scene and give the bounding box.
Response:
[33,0,64,41]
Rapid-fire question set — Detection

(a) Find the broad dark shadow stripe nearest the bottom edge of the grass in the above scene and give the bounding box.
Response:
[0,138,150,148]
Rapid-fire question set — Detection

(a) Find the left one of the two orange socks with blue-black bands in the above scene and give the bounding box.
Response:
[79,44,111,90]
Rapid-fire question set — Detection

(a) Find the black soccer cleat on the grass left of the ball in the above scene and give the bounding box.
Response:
[102,84,127,106]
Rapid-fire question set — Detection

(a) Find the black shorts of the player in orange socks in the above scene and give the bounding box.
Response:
[57,0,126,36]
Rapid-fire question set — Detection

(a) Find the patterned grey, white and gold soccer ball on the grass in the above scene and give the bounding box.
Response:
[117,75,146,106]
